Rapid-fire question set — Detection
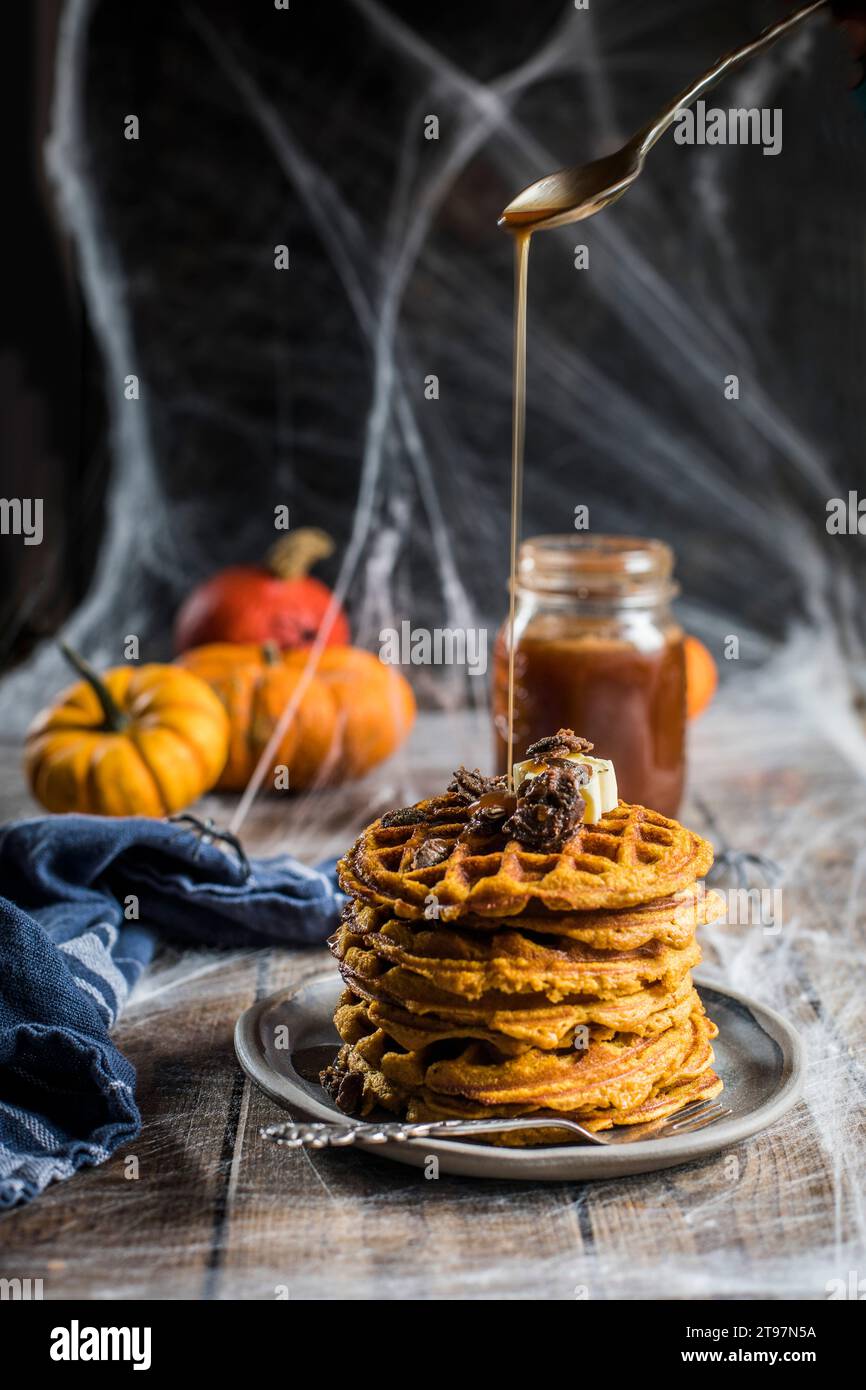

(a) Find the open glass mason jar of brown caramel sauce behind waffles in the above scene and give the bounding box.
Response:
[493,535,685,816]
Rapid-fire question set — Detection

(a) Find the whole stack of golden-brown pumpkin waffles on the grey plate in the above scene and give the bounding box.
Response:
[322,756,723,1144]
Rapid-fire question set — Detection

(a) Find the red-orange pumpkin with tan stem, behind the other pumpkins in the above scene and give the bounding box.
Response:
[174,527,350,652]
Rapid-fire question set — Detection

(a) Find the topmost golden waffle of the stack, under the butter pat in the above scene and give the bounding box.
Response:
[338,795,713,920]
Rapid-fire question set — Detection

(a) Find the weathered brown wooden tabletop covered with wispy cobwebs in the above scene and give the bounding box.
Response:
[0,706,866,1300]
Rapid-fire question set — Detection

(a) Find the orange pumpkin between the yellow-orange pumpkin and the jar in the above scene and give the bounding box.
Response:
[178,642,416,791]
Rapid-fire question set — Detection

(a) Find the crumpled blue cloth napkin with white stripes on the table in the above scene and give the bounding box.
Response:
[0,816,343,1208]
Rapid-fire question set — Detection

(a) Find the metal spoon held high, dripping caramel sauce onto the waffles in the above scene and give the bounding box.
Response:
[499,0,827,231]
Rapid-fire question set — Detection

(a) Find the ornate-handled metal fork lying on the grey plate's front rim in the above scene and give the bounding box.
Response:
[259,1101,731,1148]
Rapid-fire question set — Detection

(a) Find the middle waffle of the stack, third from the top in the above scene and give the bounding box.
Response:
[332,919,701,1004]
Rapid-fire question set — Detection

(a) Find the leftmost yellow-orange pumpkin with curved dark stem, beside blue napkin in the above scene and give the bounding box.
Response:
[25,648,228,816]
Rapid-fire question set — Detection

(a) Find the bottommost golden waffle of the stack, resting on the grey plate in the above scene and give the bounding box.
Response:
[322,1001,721,1143]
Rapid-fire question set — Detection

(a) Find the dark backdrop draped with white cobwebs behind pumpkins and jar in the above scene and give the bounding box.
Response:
[0,0,866,727]
